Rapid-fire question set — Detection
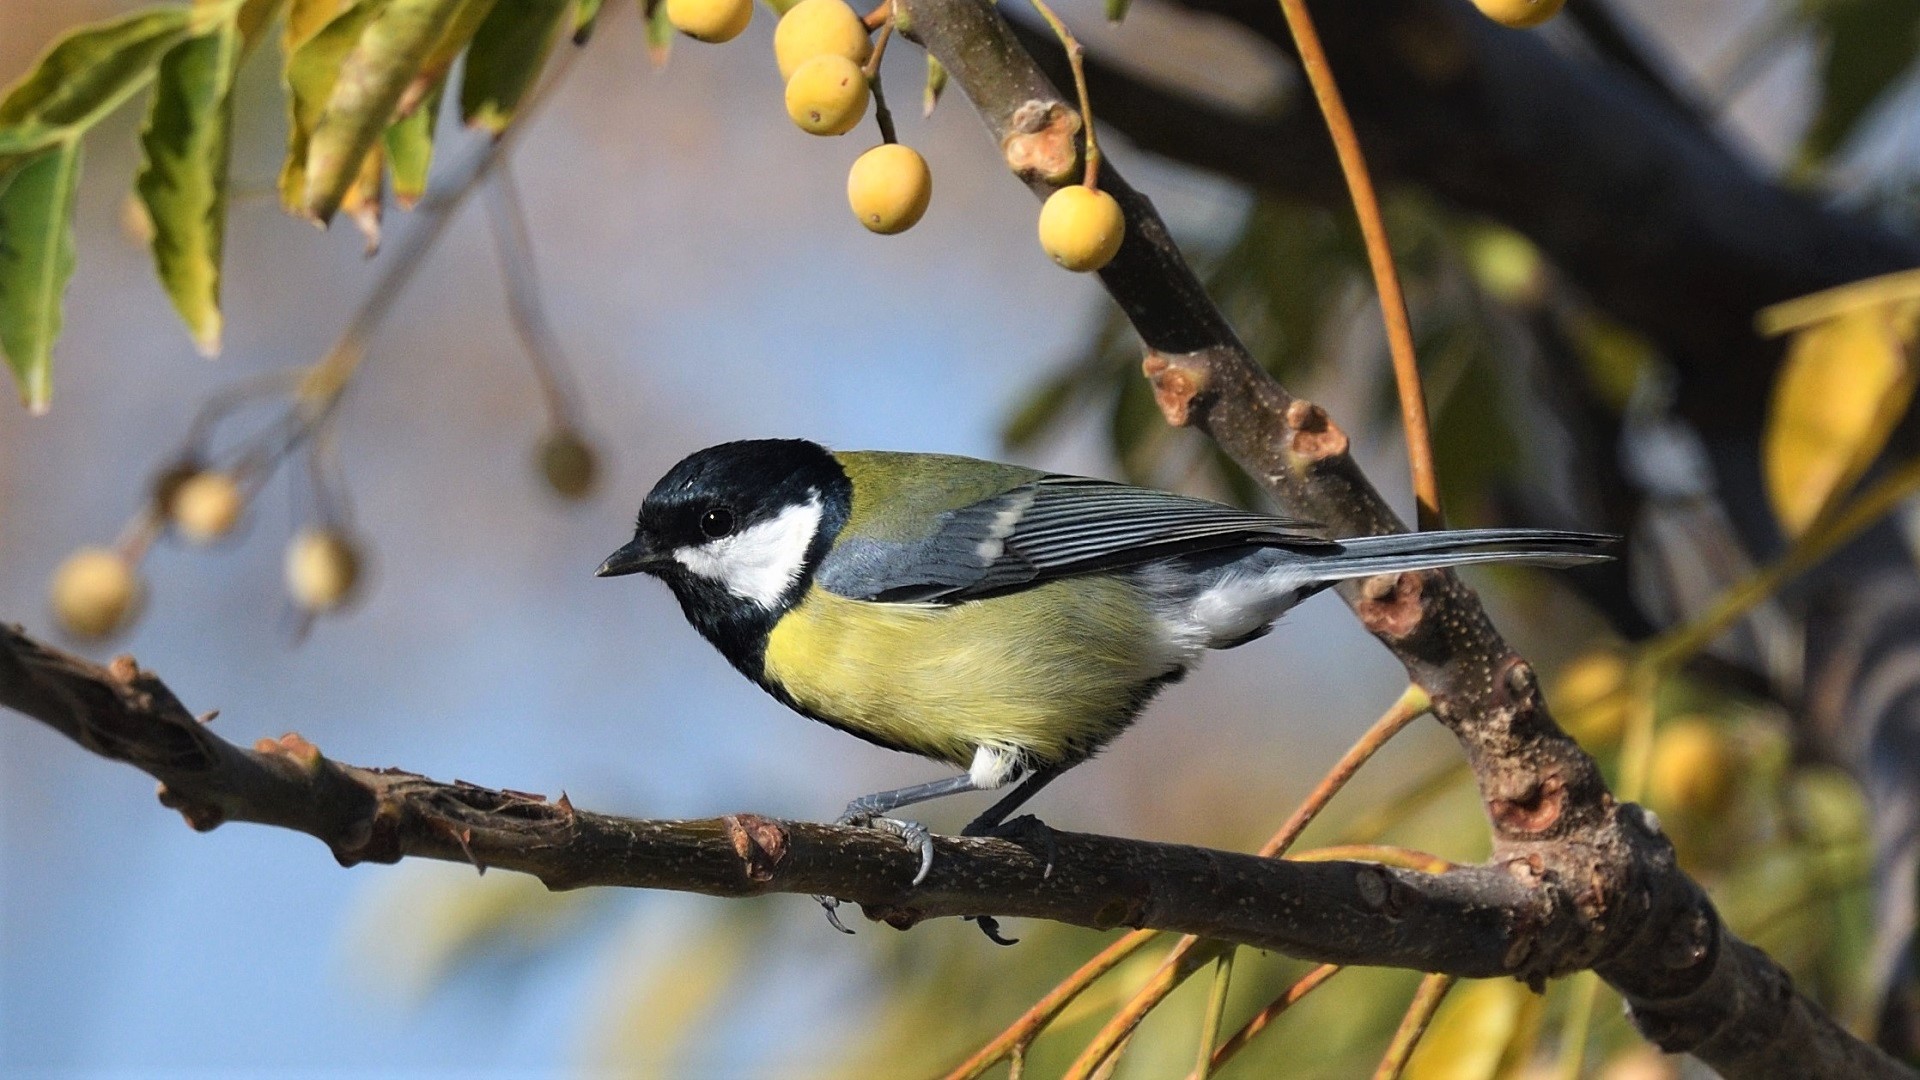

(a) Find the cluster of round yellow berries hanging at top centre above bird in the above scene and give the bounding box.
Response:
[666,0,1125,271]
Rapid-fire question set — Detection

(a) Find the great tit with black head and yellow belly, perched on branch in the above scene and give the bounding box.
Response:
[599,440,1613,884]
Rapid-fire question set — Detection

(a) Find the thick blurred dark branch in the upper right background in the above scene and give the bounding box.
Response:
[1025,0,1920,1055]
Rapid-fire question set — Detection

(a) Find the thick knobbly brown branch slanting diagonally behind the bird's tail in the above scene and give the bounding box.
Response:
[895,0,1910,1076]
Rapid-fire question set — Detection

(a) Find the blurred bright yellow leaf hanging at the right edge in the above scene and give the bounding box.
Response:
[1761,304,1914,536]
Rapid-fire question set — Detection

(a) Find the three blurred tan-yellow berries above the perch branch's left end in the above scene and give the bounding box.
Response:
[52,467,361,638]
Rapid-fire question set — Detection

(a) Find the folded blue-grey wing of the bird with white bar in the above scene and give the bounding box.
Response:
[818,475,1329,601]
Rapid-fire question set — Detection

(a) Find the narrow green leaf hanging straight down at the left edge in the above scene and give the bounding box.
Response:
[0,138,81,413]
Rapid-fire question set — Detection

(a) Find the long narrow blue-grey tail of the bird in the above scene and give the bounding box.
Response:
[1308,528,1619,582]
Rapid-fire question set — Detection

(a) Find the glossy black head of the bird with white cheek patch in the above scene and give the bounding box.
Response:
[599,438,852,664]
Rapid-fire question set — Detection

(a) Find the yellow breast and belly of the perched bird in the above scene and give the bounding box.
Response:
[764,577,1171,767]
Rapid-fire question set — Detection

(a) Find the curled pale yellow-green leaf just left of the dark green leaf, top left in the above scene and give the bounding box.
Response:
[301,0,472,221]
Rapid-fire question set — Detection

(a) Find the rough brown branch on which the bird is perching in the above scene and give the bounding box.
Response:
[0,626,1908,1076]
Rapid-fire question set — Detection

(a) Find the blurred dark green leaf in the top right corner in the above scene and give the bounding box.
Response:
[1805,0,1920,160]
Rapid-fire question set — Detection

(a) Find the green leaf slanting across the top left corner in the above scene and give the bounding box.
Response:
[0,8,192,149]
